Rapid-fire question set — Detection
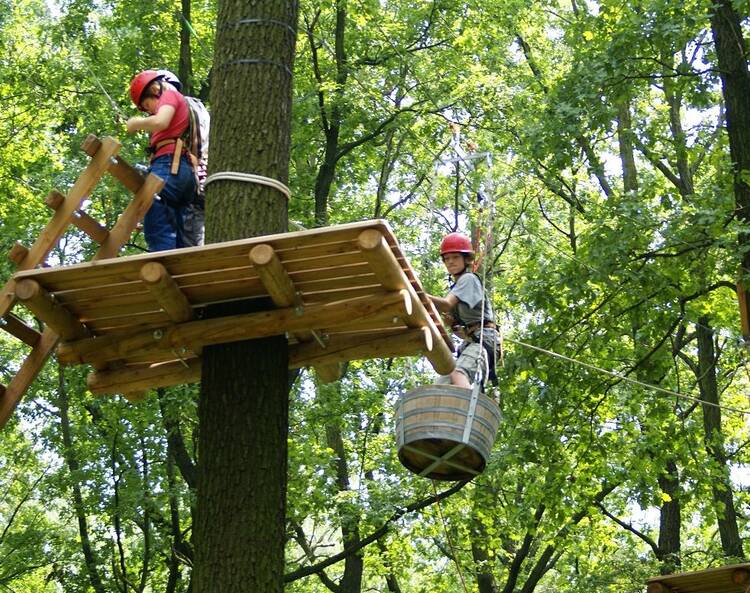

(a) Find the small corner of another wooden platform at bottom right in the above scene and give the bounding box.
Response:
[647,563,750,593]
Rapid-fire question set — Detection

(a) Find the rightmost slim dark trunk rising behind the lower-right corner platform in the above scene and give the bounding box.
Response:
[698,316,745,558]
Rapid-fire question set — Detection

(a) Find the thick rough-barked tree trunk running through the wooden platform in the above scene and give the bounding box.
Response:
[193,0,298,593]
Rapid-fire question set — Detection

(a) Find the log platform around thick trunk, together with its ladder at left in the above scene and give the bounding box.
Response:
[0,134,454,427]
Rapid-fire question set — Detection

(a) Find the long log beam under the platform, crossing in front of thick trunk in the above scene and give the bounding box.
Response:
[58,292,412,364]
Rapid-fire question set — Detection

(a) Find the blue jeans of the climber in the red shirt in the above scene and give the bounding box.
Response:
[143,154,195,251]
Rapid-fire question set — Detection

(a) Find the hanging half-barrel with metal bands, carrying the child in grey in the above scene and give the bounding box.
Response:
[396,385,500,480]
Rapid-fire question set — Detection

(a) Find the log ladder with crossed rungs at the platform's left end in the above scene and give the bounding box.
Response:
[0,135,164,429]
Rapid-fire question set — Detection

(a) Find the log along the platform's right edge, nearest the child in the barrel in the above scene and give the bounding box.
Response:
[357,229,456,375]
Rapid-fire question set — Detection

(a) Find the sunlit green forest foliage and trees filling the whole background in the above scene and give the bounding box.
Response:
[0,0,750,593]
